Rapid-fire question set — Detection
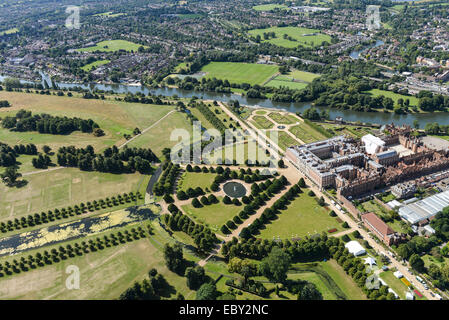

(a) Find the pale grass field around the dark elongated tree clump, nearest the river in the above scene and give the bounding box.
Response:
[0,91,175,151]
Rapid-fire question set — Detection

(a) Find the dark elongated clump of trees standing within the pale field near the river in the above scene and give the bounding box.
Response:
[2,109,99,134]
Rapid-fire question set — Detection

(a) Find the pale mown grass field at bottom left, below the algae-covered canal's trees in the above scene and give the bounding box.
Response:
[0,224,195,300]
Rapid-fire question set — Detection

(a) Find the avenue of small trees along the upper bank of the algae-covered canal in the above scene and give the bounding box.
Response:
[0,191,143,233]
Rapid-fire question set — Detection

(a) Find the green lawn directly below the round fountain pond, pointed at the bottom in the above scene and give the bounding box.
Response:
[182,197,243,232]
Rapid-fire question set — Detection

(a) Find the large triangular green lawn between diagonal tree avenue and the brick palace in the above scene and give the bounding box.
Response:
[257,189,341,240]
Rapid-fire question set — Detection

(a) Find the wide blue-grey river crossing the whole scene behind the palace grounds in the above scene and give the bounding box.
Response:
[0,65,449,128]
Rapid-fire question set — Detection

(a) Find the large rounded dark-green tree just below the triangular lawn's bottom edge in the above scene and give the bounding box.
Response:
[259,247,291,282]
